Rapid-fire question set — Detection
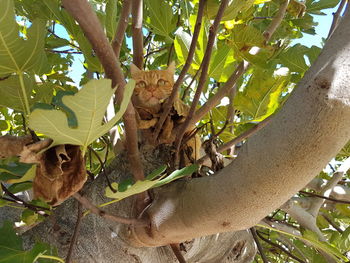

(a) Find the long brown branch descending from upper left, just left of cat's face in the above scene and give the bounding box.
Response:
[62,0,147,212]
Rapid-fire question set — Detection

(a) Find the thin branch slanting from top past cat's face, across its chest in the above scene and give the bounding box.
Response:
[153,0,207,140]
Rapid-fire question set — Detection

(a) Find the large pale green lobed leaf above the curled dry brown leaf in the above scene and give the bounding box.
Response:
[29,79,135,154]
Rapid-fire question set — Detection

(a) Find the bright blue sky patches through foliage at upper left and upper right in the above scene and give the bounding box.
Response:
[63,5,337,85]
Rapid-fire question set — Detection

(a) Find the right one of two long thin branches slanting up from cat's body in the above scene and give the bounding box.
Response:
[175,0,228,167]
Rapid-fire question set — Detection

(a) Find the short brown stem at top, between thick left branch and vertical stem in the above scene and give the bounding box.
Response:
[112,0,131,60]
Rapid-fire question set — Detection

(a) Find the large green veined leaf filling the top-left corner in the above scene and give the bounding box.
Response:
[0,0,46,74]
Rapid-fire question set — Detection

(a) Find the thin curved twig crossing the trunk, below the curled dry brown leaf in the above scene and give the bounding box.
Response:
[73,193,148,226]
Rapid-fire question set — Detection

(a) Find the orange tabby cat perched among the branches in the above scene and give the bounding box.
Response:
[130,62,201,163]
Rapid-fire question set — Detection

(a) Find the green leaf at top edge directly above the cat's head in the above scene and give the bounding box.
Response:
[145,0,176,42]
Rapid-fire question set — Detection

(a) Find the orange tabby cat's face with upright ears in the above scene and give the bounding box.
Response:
[130,62,175,109]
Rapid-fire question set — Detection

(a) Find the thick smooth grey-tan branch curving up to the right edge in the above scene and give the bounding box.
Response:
[133,11,350,246]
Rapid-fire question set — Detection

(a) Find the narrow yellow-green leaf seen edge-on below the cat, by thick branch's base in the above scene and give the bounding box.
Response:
[102,165,198,201]
